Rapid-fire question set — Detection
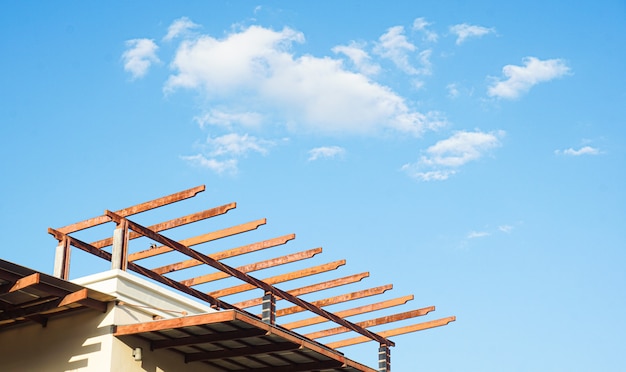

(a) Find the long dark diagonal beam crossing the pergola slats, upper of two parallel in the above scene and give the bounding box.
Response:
[105,211,395,346]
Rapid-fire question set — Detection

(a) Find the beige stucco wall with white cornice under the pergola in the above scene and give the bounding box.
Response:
[0,270,219,372]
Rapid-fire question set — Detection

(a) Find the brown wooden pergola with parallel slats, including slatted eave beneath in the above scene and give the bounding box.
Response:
[48,186,455,371]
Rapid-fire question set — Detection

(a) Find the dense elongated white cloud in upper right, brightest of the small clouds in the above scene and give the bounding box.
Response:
[488,57,570,99]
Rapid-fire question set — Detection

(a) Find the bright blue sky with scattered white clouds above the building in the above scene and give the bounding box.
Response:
[0,1,626,371]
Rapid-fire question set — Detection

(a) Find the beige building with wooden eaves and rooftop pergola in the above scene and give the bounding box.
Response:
[0,186,448,372]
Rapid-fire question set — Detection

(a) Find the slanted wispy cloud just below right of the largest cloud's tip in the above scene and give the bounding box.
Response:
[402,131,504,181]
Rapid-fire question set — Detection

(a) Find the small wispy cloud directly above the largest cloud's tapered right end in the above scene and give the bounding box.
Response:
[374,26,419,75]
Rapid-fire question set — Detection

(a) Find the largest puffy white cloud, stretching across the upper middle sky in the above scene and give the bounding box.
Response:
[164,26,445,136]
